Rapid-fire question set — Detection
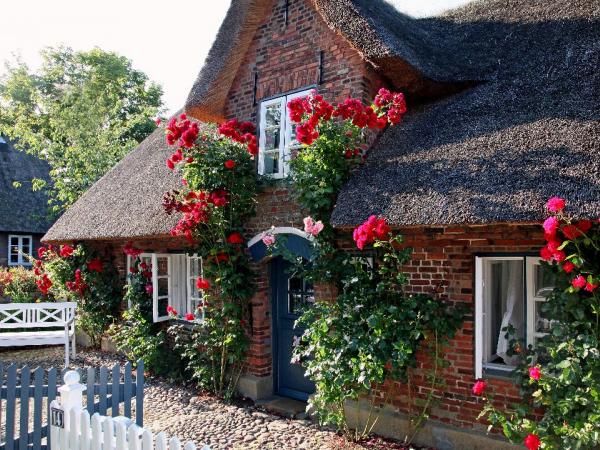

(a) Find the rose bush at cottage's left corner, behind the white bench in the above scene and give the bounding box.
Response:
[43,244,121,347]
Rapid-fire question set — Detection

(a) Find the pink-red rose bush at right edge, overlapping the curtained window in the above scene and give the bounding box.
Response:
[473,197,600,450]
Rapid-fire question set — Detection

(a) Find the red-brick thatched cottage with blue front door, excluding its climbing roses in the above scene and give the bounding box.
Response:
[44,0,600,448]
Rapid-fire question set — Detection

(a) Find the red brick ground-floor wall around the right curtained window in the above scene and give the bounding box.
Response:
[340,224,544,431]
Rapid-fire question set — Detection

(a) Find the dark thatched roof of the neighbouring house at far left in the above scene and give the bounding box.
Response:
[0,137,50,233]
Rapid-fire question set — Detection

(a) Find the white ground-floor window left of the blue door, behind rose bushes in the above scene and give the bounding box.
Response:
[127,253,204,322]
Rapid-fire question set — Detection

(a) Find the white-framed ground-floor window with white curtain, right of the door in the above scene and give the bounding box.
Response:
[475,256,554,378]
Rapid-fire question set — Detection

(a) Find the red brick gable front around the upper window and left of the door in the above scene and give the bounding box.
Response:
[225,0,384,376]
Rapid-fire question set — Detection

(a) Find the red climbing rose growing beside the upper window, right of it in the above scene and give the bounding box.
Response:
[288,88,406,225]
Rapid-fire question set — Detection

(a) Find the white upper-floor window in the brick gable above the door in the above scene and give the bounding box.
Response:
[258,91,310,178]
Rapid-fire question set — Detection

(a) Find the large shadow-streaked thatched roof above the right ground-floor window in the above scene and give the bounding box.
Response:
[333,0,600,226]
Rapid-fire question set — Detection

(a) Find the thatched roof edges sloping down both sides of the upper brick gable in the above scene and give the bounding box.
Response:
[185,0,473,122]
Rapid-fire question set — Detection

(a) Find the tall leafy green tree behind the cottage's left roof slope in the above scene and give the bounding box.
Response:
[0,47,162,214]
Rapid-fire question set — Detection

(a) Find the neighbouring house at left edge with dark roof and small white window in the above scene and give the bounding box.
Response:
[0,136,52,267]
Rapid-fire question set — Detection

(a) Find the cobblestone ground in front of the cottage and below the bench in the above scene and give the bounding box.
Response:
[0,347,390,450]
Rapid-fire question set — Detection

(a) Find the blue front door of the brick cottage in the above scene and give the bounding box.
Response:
[271,258,315,400]
